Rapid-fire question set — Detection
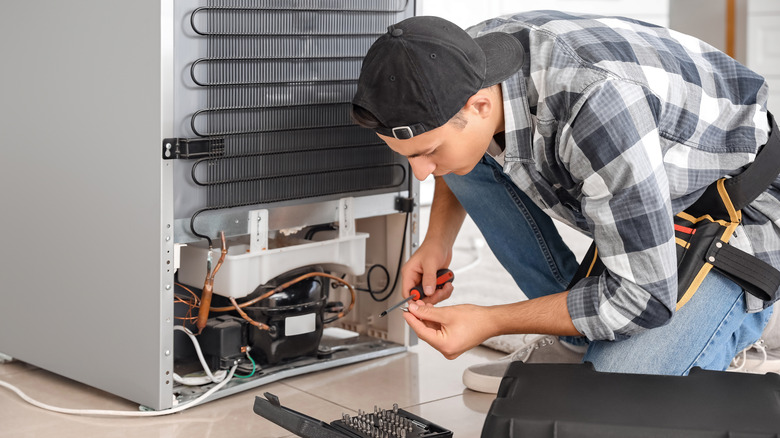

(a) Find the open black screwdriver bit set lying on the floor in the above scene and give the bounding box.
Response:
[254,393,452,438]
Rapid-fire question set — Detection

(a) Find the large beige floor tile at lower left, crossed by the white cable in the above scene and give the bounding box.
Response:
[0,371,343,438]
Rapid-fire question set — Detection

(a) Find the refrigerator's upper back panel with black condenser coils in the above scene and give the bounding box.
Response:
[174,0,414,218]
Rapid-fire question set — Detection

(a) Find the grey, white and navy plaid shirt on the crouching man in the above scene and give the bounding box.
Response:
[469,11,780,340]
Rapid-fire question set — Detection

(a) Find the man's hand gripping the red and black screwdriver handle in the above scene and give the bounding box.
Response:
[401,239,454,304]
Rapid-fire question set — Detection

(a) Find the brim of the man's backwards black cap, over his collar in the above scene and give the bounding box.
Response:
[474,32,525,88]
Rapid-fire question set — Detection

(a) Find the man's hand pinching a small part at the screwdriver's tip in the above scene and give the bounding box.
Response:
[404,301,495,359]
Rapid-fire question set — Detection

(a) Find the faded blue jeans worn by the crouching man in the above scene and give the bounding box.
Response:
[444,156,772,375]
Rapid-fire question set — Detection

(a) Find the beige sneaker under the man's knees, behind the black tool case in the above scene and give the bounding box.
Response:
[463,335,587,394]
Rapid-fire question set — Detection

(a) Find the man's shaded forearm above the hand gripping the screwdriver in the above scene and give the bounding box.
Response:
[425,177,466,248]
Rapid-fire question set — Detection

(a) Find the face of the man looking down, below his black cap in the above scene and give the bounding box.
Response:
[377,111,493,181]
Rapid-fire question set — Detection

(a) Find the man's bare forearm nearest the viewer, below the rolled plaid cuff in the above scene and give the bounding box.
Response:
[485,291,582,336]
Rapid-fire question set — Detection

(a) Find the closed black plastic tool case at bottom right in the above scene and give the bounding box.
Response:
[482,361,780,438]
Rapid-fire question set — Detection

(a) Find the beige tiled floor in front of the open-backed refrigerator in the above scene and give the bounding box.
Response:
[0,344,501,438]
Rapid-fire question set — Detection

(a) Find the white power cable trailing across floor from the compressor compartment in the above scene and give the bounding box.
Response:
[0,325,238,417]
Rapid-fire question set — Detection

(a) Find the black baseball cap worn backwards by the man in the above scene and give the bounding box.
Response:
[352,17,523,140]
